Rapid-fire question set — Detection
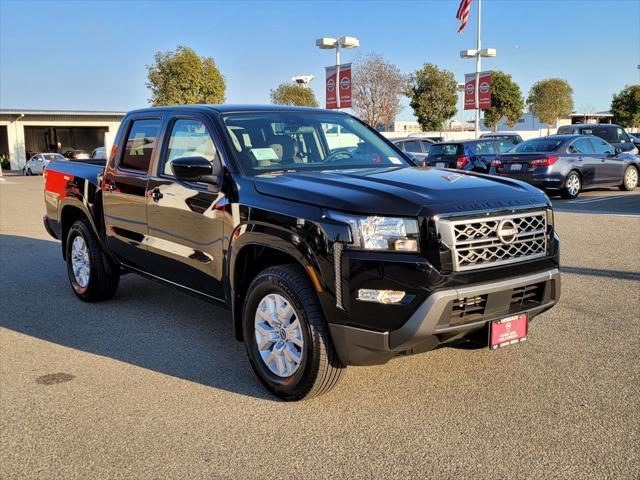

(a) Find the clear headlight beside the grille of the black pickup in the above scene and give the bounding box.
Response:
[331,213,418,252]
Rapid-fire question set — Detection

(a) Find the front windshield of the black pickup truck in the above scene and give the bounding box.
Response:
[222,111,410,175]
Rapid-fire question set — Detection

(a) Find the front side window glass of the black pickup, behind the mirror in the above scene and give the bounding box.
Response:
[163,119,217,175]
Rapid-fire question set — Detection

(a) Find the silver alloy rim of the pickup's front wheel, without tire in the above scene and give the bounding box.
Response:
[254,293,304,378]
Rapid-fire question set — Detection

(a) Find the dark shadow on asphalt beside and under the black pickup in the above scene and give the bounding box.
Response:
[0,235,275,401]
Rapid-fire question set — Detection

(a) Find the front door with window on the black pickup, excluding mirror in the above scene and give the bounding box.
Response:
[146,116,224,300]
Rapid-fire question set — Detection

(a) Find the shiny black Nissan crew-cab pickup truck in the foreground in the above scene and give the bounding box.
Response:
[44,105,560,400]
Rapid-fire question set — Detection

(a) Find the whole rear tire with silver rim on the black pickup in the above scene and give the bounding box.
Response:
[65,219,120,302]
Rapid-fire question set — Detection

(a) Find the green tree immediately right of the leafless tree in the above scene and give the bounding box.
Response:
[407,63,458,131]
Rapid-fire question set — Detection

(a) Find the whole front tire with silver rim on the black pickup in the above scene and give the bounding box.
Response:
[242,265,345,401]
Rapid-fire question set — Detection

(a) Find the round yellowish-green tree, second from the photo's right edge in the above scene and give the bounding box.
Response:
[527,78,573,133]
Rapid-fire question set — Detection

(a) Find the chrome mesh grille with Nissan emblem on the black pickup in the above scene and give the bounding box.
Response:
[438,211,547,271]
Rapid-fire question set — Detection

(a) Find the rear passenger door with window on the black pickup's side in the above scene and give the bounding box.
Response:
[102,116,162,271]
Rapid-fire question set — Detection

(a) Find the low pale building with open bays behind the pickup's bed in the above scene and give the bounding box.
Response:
[0,109,125,170]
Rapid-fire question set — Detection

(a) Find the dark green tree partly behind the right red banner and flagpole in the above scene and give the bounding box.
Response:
[484,70,524,132]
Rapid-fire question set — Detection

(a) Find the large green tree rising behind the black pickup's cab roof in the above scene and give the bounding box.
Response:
[147,45,227,106]
